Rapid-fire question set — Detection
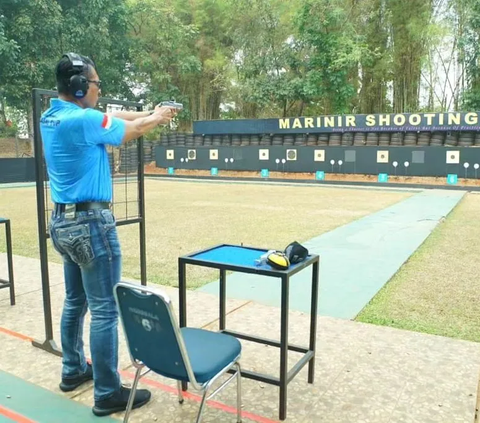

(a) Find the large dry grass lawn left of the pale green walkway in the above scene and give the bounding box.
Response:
[0,180,412,288]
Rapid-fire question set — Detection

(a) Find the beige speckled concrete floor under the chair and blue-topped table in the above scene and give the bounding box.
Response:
[0,254,480,423]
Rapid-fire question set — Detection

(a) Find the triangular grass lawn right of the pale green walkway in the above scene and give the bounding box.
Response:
[356,194,480,342]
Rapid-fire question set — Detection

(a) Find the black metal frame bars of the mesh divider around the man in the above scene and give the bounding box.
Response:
[32,88,147,356]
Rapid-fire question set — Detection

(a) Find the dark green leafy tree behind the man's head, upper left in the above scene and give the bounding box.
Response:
[0,0,132,139]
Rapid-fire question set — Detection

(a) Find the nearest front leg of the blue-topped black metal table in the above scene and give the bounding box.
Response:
[279,276,289,420]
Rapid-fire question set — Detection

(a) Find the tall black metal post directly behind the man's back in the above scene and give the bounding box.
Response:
[32,89,62,356]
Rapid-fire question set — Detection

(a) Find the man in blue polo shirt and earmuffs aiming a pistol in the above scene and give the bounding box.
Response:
[40,53,175,416]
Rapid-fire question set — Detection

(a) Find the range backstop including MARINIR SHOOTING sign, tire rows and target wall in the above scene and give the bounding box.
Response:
[154,112,480,178]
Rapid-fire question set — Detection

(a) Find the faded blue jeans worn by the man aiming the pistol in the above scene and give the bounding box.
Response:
[49,210,122,400]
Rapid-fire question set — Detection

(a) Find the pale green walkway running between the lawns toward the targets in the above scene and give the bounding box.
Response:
[199,190,465,319]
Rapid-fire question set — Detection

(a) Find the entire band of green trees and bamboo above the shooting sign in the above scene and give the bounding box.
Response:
[0,0,480,132]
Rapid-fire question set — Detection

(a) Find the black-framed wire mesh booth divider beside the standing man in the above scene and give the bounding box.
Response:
[32,88,147,356]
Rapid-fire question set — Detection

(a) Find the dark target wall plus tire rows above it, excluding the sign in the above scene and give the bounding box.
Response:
[153,131,480,178]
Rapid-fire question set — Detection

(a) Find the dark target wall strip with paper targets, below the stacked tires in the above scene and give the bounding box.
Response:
[155,146,480,178]
